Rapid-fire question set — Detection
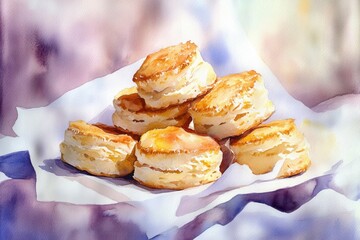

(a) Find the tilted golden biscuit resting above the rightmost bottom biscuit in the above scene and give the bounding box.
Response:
[189,70,275,139]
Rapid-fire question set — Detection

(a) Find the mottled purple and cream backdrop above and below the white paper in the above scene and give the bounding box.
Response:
[0,0,360,239]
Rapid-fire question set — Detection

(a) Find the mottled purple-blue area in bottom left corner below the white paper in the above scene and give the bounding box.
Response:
[0,179,147,240]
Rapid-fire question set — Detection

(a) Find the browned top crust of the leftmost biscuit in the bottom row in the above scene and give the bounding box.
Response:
[67,120,135,145]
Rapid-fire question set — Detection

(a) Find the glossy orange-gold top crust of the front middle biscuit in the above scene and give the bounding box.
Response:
[137,126,220,154]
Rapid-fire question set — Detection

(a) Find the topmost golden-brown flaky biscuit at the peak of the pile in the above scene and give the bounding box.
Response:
[133,41,216,109]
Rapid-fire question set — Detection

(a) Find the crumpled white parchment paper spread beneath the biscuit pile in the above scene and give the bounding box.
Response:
[0,47,360,237]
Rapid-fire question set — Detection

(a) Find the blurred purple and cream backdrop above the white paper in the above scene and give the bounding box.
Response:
[0,0,360,135]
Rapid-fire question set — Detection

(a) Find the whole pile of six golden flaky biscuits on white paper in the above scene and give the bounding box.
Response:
[61,39,310,189]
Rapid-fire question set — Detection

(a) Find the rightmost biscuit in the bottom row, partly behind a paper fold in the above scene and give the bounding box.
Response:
[230,119,311,178]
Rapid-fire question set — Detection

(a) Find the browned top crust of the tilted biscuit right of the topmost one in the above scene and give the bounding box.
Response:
[191,70,262,114]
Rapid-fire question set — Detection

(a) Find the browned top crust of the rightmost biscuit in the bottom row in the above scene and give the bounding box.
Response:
[231,118,296,146]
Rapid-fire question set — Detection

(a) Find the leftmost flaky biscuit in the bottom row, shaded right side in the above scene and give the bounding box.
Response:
[60,121,136,177]
